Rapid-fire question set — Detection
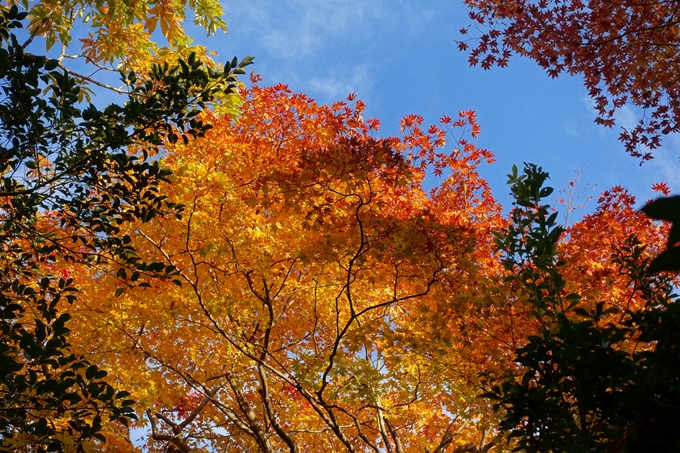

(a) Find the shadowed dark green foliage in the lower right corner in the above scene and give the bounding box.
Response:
[485,164,680,453]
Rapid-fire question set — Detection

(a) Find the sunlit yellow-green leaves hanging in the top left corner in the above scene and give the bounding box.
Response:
[3,0,226,95]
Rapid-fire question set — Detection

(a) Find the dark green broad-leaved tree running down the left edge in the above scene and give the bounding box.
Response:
[0,6,248,452]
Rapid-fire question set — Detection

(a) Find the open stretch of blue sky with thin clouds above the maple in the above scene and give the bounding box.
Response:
[191,0,680,215]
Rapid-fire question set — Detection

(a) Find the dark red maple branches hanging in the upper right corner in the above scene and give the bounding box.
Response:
[458,0,680,161]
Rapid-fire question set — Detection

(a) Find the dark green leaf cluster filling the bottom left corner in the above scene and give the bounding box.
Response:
[0,261,135,452]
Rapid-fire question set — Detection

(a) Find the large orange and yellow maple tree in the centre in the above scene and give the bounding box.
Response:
[66,85,504,453]
